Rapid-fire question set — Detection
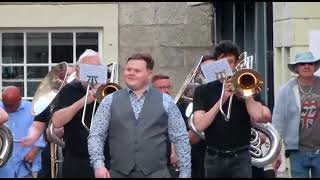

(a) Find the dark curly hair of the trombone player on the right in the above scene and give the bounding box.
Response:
[213,40,240,60]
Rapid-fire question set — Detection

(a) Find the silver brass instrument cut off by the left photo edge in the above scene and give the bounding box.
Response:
[0,125,13,168]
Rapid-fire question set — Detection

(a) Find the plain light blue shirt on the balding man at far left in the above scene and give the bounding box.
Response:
[0,100,45,178]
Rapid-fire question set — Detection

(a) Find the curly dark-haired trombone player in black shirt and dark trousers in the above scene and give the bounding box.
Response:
[193,41,271,178]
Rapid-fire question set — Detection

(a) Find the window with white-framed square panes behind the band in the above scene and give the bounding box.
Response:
[0,30,101,99]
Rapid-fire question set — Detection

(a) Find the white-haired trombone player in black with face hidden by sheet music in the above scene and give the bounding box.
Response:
[52,49,110,178]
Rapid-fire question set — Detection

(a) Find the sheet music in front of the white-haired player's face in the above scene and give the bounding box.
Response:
[80,64,108,84]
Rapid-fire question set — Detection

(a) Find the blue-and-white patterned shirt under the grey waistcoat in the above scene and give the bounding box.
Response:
[88,86,191,177]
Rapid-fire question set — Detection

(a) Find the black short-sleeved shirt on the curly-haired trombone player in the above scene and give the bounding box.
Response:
[193,81,264,150]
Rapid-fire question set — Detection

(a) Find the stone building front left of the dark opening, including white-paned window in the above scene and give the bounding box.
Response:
[0,2,213,99]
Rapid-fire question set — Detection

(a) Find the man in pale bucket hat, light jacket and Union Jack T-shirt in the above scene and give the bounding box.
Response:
[272,51,320,178]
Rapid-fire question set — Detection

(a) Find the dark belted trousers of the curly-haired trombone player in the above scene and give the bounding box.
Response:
[205,149,252,178]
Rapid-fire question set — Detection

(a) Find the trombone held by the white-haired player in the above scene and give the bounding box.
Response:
[81,62,121,131]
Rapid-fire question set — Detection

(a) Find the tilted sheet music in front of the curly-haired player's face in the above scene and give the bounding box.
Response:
[201,59,233,83]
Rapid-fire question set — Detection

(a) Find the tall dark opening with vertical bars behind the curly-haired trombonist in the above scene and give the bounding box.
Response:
[214,1,274,109]
